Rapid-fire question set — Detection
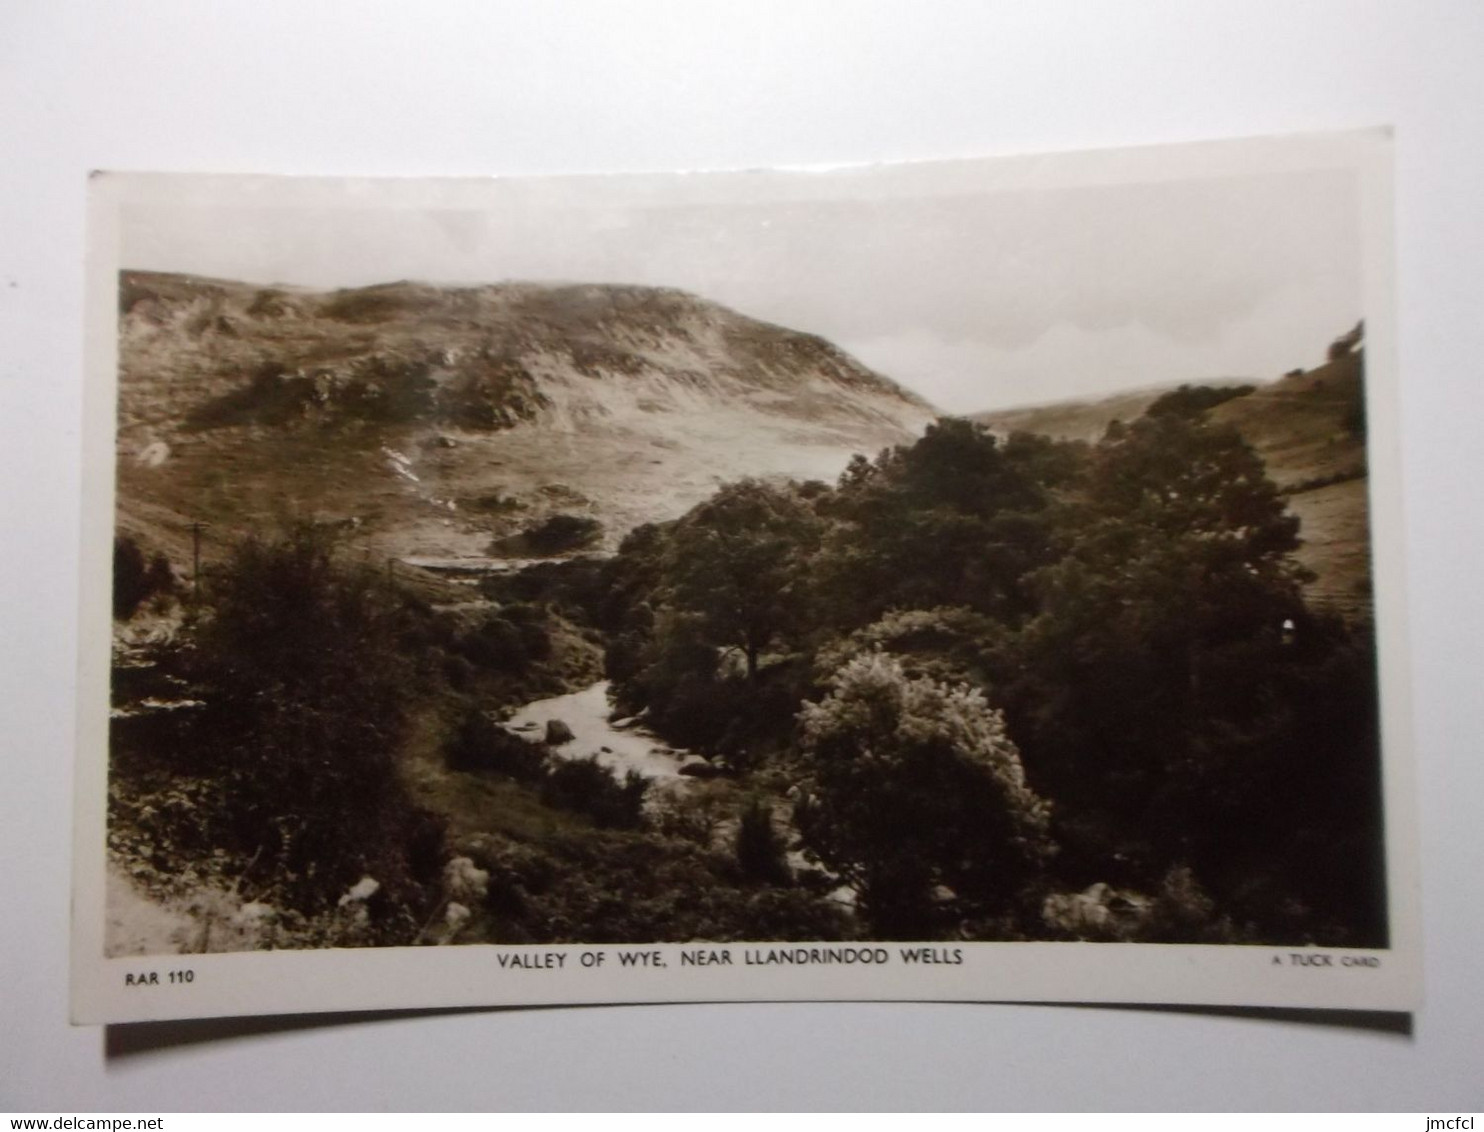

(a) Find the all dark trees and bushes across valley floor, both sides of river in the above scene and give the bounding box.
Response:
[114,387,1386,945]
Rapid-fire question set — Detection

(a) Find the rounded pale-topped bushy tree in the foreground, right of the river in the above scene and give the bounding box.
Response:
[795,651,1052,939]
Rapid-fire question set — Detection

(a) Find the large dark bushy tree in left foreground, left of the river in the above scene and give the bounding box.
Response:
[183,525,441,912]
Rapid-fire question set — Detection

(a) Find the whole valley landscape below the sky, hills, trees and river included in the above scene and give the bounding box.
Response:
[108,281,1388,954]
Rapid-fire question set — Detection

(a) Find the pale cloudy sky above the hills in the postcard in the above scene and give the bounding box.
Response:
[120,163,1362,412]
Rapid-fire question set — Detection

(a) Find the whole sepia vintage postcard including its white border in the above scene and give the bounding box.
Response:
[73,131,1420,1022]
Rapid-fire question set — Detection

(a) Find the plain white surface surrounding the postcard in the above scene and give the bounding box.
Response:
[0,0,1484,1114]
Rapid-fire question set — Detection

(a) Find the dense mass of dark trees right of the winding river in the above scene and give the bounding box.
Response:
[592,403,1385,944]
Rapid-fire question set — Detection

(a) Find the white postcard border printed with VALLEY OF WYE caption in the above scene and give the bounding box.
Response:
[71,129,1422,1024]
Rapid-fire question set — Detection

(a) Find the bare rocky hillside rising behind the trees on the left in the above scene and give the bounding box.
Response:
[117,272,933,562]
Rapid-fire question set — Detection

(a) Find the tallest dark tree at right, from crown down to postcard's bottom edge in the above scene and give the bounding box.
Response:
[997,412,1374,918]
